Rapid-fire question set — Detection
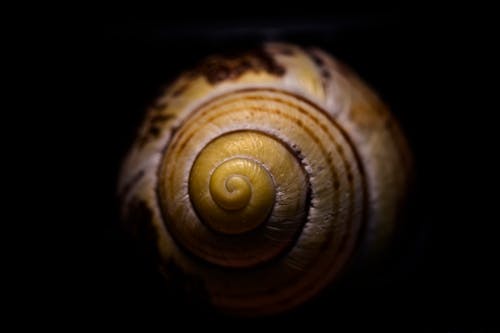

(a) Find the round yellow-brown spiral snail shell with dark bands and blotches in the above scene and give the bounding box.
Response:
[119,43,411,315]
